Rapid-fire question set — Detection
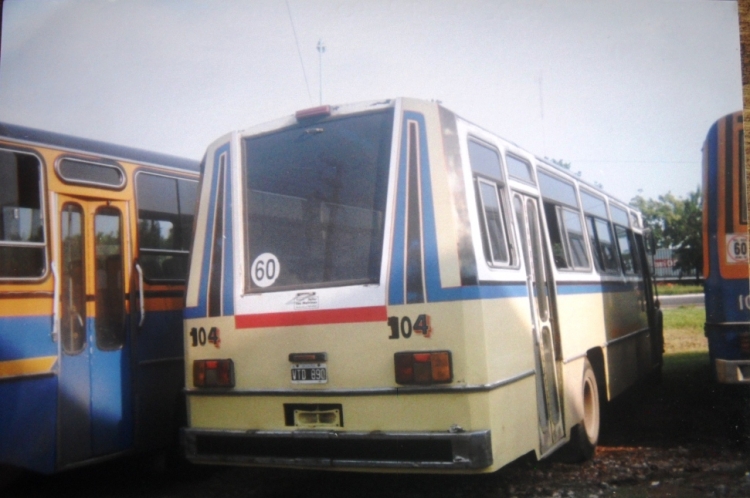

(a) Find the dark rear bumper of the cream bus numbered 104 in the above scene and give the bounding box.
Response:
[182,428,492,471]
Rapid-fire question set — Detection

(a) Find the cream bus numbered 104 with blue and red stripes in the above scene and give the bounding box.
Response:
[182,98,662,473]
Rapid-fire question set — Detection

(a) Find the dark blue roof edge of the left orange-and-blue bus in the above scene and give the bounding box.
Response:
[0,122,200,172]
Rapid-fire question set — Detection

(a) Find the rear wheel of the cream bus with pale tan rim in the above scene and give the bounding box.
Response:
[559,359,601,462]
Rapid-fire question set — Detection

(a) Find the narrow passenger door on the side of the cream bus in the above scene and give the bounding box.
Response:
[513,193,565,454]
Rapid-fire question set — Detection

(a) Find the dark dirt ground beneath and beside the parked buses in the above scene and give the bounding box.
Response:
[5,353,750,498]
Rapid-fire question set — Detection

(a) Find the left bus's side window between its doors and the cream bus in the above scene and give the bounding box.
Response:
[136,173,198,280]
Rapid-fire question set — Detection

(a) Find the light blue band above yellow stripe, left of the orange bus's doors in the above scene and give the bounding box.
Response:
[0,315,57,361]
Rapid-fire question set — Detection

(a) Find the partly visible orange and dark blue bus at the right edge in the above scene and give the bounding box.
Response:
[703,111,750,384]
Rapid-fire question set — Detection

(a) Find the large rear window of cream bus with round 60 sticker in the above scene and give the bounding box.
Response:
[243,110,393,292]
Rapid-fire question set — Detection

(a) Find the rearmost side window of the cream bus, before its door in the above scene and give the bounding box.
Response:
[468,140,513,266]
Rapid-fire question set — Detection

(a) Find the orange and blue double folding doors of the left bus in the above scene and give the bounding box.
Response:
[56,195,132,466]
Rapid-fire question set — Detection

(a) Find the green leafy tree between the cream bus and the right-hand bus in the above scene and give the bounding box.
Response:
[630,187,703,275]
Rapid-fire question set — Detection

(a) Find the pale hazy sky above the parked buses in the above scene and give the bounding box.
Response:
[0,0,742,201]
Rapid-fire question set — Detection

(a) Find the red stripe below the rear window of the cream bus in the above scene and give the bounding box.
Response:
[234,306,388,329]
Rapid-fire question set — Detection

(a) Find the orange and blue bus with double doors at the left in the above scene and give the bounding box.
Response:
[0,124,199,473]
